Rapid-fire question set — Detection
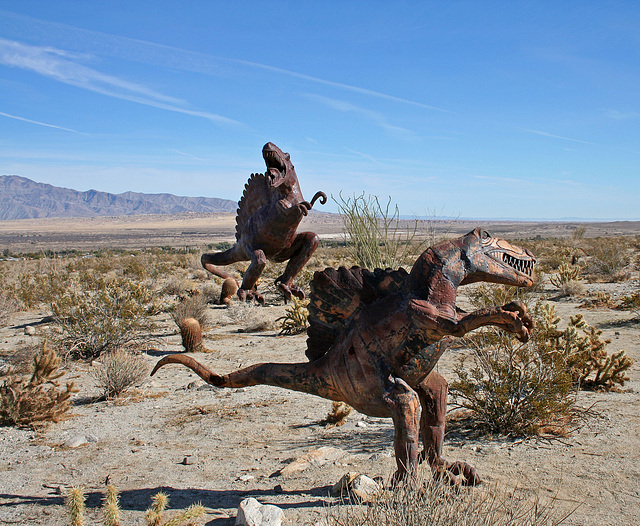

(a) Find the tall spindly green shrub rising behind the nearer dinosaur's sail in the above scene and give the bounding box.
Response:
[334,193,418,270]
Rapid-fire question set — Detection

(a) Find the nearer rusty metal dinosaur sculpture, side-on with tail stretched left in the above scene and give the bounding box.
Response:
[151,229,535,485]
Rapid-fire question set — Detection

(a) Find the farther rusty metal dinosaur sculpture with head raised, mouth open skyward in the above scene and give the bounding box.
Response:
[202,142,327,303]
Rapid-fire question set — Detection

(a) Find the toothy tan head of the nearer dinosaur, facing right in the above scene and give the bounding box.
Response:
[457,228,536,287]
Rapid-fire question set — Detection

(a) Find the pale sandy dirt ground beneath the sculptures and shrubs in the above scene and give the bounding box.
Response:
[0,217,640,526]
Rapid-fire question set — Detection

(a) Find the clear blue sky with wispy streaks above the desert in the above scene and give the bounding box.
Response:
[0,0,640,220]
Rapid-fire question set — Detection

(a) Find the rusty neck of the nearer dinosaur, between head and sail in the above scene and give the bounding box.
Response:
[408,249,465,319]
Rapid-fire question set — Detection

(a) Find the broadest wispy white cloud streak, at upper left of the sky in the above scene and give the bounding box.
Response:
[0,38,240,125]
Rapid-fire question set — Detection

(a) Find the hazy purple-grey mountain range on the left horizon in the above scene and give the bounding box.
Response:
[0,175,238,220]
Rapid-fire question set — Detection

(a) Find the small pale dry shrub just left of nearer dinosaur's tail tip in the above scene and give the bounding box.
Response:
[91,349,149,398]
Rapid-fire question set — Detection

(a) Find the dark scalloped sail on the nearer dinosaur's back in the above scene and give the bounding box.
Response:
[306,267,408,361]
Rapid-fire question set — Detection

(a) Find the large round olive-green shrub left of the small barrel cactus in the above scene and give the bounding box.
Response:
[51,272,157,359]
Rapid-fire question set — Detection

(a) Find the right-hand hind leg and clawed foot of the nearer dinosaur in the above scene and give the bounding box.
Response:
[416,371,481,486]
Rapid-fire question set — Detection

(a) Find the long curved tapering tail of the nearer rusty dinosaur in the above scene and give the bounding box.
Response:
[151,354,342,401]
